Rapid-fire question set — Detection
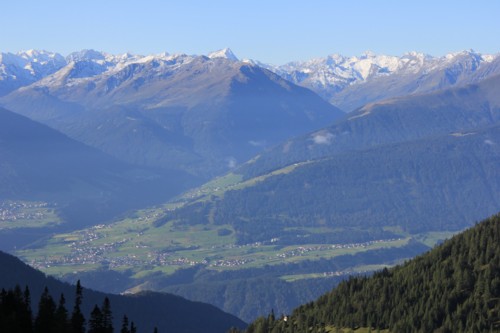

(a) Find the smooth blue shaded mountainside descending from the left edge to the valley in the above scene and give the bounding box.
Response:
[0,109,195,244]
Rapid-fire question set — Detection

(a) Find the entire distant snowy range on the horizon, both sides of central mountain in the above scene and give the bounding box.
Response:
[0,48,500,112]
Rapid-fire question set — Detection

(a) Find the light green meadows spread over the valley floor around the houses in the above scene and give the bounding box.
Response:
[17,201,420,280]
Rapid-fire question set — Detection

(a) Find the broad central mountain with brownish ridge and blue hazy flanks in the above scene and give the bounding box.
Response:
[0,53,342,176]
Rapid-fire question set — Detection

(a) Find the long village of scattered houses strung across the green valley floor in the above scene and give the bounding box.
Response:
[25,209,408,276]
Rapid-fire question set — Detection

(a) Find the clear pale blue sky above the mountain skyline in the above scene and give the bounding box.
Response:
[0,0,500,64]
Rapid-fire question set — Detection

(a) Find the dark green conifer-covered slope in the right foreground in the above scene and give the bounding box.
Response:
[242,215,500,333]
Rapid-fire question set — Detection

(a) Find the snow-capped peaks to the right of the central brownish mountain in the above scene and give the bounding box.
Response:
[270,50,500,111]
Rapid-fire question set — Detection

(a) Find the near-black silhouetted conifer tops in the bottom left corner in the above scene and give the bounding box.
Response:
[0,281,157,333]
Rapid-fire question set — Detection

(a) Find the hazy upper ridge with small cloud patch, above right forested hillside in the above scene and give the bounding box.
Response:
[237,71,500,177]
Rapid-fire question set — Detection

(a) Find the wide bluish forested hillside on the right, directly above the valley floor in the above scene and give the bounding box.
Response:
[165,122,500,244]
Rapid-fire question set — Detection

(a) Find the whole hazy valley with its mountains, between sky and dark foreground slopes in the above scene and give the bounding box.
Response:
[0,49,500,332]
